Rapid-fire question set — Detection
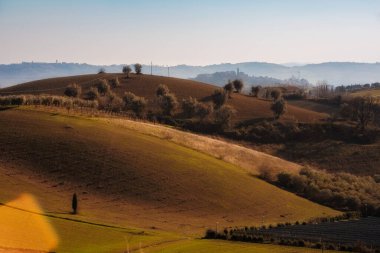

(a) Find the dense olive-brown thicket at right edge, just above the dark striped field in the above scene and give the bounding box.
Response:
[274,168,380,216]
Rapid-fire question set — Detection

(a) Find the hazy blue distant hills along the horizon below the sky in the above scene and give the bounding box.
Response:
[0,62,380,87]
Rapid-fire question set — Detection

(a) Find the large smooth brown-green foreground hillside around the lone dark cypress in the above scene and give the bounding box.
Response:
[0,109,338,252]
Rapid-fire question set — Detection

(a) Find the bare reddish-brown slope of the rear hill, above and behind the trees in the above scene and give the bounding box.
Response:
[0,74,327,122]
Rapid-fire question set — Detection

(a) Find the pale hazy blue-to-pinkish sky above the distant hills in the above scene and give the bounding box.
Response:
[0,0,380,65]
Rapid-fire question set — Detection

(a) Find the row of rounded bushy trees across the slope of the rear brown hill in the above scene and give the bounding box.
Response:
[64,78,238,131]
